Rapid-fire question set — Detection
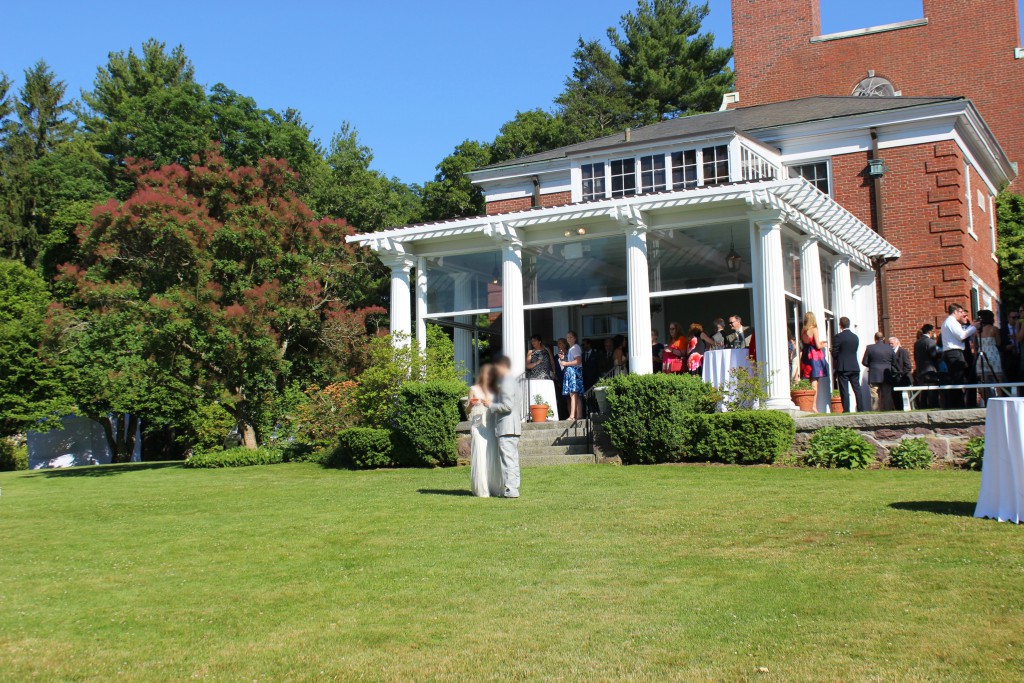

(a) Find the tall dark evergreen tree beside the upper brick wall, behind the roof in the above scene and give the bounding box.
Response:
[608,0,733,123]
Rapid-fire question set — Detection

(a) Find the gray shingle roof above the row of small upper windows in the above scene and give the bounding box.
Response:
[477,96,964,170]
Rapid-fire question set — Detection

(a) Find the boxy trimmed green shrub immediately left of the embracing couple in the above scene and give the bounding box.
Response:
[394,380,466,467]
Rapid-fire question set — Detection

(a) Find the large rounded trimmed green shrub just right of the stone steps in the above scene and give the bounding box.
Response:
[604,373,720,465]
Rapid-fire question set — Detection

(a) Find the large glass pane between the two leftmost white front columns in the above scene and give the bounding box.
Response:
[427,251,502,314]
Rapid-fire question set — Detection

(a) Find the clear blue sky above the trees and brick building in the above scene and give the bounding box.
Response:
[0,0,1015,182]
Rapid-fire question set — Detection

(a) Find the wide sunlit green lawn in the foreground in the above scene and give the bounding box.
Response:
[0,465,1024,681]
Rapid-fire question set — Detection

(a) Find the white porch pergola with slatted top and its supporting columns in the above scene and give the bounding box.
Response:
[348,178,900,409]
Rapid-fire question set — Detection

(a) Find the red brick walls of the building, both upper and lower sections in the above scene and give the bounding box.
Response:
[727,0,1024,338]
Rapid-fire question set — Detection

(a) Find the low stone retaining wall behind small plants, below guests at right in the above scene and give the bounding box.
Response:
[795,410,985,466]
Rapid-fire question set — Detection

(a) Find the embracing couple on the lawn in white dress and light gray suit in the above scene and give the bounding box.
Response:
[469,355,522,498]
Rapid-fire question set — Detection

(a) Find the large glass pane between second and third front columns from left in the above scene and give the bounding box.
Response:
[522,236,626,304]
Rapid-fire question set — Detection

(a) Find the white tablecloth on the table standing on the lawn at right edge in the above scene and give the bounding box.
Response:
[974,398,1024,523]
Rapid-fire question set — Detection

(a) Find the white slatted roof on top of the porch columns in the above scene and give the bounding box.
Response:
[348,178,900,269]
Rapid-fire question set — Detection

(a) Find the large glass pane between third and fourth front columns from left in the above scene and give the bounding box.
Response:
[647,223,751,292]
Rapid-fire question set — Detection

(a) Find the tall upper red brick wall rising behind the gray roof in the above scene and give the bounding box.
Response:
[732,0,1024,191]
